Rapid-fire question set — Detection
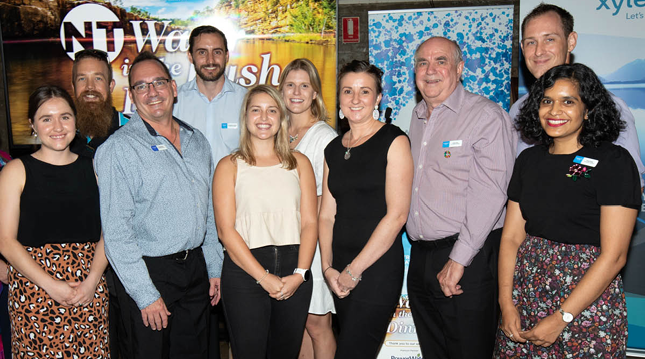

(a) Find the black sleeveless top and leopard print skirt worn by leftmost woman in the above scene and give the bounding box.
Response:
[9,156,110,359]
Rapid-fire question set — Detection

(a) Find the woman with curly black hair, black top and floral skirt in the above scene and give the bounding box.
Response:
[495,64,641,358]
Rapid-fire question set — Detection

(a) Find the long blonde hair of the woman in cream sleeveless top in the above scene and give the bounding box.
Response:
[231,85,298,170]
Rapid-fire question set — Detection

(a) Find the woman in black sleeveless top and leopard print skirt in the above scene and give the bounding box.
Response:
[0,86,109,358]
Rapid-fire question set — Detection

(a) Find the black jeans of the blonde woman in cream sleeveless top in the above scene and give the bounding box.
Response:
[222,245,312,359]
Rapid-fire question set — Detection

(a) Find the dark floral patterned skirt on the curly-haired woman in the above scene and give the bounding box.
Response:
[494,236,627,359]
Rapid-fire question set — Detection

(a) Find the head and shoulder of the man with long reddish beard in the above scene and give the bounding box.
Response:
[71,49,128,157]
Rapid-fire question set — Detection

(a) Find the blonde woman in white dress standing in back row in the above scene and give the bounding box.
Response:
[278,59,338,359]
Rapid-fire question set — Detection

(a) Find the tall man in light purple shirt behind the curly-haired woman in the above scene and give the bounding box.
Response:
[509,4,645,187]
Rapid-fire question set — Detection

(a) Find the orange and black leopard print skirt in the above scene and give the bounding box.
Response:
[9,243,110,359]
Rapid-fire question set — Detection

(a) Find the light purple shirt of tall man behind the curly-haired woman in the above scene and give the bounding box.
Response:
[508,92,645,187]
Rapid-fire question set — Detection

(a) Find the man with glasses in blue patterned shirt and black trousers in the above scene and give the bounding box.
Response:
[95,52,223,359]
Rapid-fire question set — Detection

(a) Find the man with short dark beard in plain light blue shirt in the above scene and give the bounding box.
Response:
[173,25,246,359]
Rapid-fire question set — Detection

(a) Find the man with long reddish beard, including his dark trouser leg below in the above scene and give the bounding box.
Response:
[71,49,129,359]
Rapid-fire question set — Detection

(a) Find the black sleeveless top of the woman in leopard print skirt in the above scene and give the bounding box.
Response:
[18,156,101,247]
